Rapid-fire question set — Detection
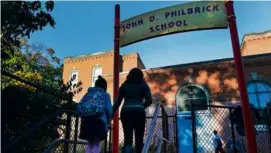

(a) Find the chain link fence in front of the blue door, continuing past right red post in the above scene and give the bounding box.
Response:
[192,105,271,153]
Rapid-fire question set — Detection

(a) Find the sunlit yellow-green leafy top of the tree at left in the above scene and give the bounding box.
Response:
[1,41,62,89]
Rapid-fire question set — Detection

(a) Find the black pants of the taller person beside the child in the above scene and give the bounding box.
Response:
[121,108,146,153]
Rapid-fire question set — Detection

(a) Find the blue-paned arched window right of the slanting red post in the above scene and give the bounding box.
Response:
[247,81,271,108]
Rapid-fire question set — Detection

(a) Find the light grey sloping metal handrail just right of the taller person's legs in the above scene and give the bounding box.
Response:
[142,103,160,153]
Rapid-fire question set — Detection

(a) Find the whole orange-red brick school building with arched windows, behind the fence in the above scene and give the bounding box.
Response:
[63,31,271,152]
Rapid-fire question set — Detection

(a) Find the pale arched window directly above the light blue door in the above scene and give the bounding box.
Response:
[176,84,209,112]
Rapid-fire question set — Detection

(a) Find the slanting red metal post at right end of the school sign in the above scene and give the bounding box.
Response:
[225,1,257,153]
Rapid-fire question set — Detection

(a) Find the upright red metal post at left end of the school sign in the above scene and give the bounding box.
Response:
[112,4,120,153]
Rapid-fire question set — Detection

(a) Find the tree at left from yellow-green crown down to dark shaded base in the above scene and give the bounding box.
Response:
[1,44,82,153]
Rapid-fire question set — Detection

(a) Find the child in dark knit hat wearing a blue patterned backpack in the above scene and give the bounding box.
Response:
[77,76,112,153]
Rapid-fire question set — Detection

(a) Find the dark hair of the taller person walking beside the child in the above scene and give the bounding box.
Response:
[125,68,144,84]
